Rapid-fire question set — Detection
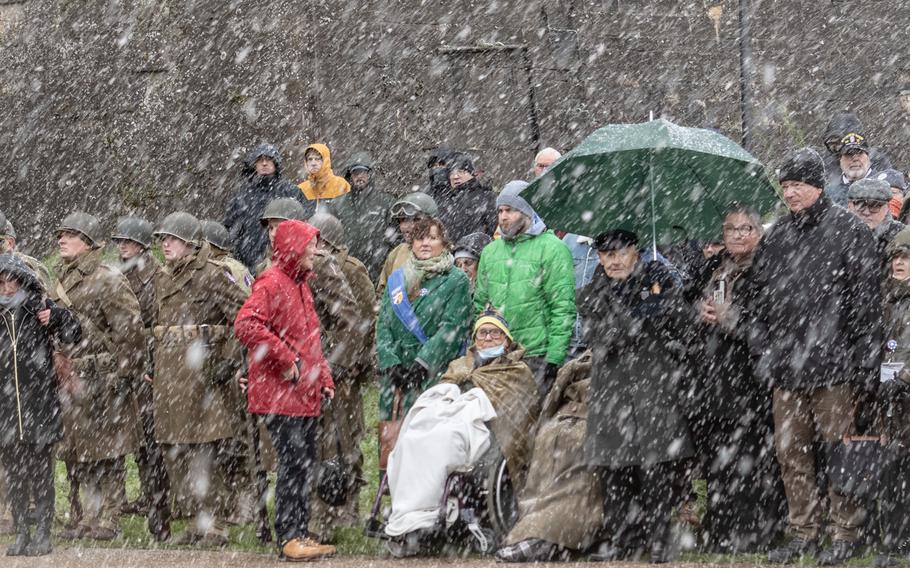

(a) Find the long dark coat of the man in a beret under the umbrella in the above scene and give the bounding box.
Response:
[578,262,693,468]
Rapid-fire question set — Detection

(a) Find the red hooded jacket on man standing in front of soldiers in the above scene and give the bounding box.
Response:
[234,221,335,416]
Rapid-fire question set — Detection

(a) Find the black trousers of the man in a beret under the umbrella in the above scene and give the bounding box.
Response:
[601,461,687,550]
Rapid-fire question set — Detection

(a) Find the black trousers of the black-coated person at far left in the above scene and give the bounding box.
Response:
[0,443,54,530]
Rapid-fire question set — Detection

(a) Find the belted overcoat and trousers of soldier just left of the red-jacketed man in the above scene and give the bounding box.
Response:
[152,245,246,536]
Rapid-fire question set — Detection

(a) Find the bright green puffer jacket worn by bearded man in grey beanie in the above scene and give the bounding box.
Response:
[474,231,575,365]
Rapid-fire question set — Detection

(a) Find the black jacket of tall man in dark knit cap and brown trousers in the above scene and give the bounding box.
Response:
[740,195,883,390]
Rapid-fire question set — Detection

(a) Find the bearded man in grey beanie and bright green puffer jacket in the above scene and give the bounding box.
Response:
[474,180,576,397]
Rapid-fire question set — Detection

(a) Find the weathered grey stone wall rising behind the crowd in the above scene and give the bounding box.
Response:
[0,0,910,253]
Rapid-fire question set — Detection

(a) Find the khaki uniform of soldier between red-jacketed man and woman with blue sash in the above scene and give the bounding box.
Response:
[310,247,376,540]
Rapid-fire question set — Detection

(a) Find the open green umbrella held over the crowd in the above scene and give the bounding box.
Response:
[522,119,780,251]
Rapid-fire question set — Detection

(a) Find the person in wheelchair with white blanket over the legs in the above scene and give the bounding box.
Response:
[385,311,540,556]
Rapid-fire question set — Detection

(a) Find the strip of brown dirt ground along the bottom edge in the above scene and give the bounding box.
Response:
[0,548,772,568]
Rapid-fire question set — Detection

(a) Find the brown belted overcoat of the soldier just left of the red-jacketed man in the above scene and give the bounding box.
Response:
[152,244,246,444]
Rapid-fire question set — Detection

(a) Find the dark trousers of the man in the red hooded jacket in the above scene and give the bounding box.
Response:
[265,414,319,545]
